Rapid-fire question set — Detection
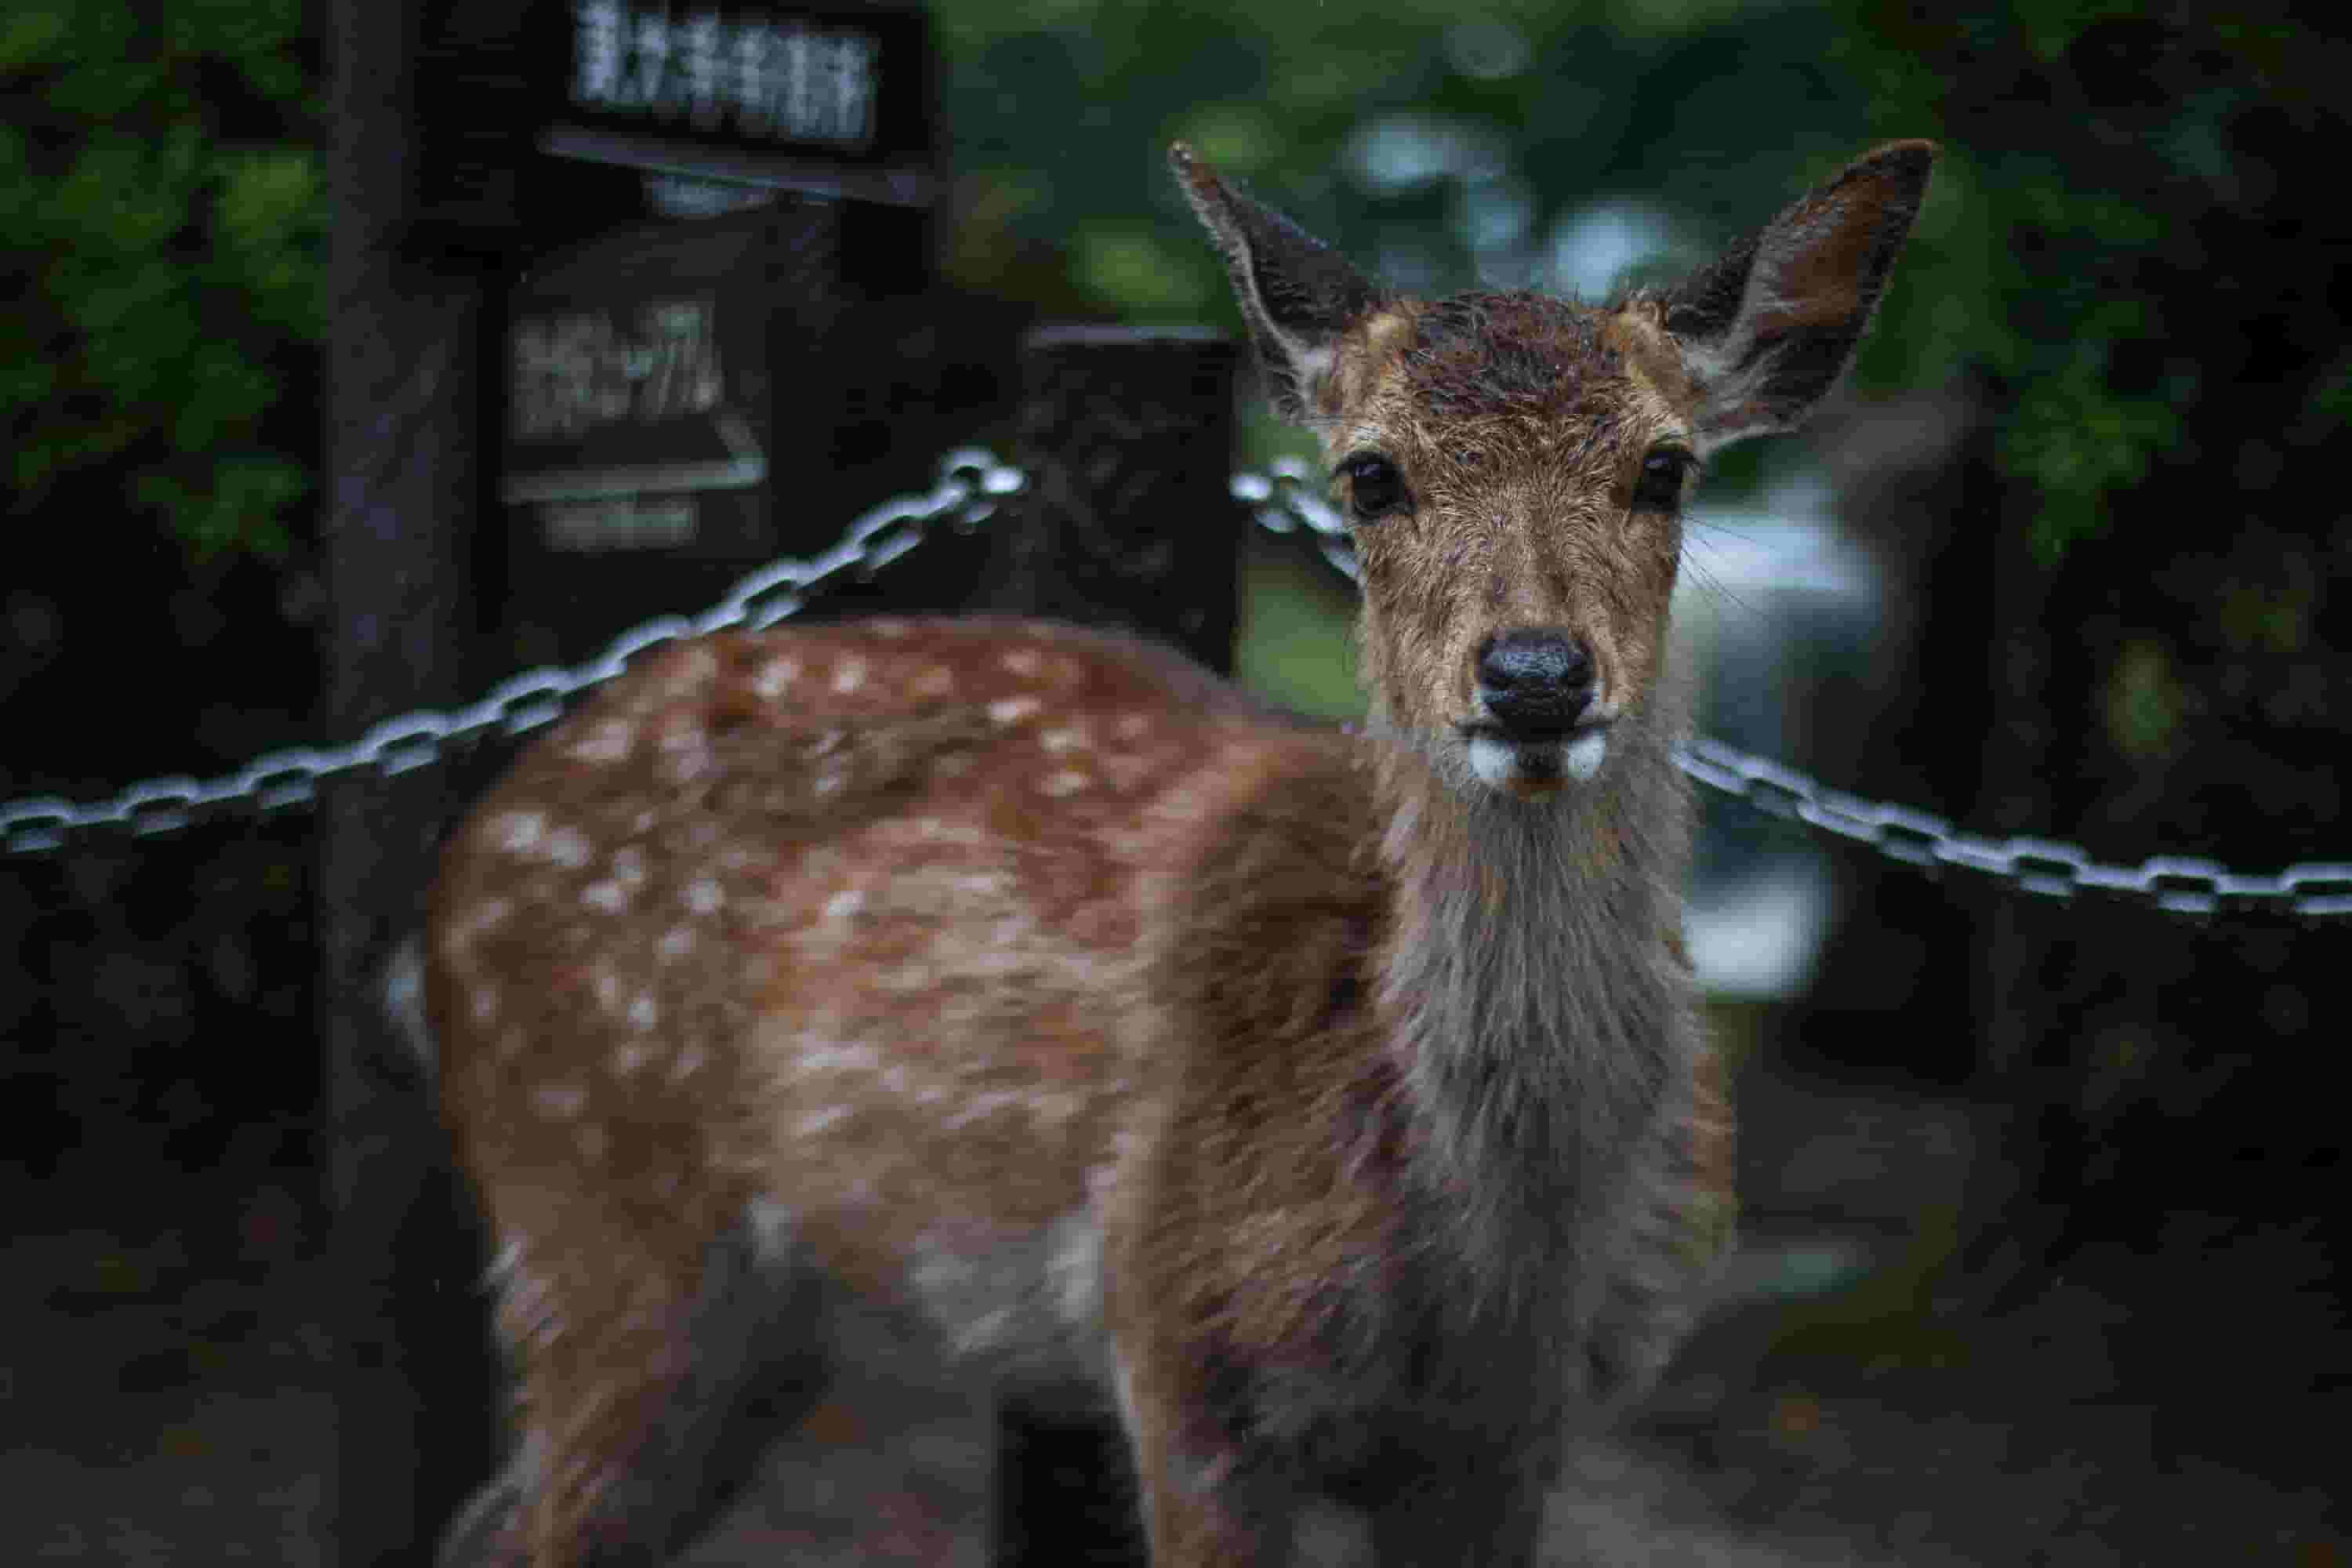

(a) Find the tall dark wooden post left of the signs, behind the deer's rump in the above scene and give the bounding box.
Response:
[318,0,496,1566]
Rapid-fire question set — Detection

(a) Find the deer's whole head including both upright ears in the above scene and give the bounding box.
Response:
[1171,141,1936,801]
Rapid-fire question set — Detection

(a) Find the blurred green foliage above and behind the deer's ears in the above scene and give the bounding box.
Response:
[938,0,2352,562]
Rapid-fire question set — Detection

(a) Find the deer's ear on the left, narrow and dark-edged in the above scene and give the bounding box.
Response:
[1169,141,1378,421]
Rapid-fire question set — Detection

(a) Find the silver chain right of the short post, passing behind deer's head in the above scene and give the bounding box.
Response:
[1232,461,2352,914]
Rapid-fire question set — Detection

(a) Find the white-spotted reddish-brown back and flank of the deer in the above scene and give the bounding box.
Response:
[430,621,1348,1349]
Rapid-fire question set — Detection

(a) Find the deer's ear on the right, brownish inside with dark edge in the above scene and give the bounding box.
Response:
[1665,141,1936,452]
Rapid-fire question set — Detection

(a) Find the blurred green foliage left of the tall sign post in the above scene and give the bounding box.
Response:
[0,0,327,557]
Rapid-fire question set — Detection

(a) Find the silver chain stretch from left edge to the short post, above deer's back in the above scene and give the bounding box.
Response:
[0,447,1025,853]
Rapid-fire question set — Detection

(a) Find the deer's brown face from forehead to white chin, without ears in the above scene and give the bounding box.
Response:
[1312,294,1696,799]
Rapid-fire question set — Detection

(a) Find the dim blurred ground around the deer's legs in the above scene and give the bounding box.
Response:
[0,1074,2352,1568]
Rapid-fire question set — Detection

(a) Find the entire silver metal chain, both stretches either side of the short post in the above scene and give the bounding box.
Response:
[0,447,2352,916]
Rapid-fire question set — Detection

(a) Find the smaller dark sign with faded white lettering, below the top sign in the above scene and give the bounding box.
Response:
[496,200,842,659]
